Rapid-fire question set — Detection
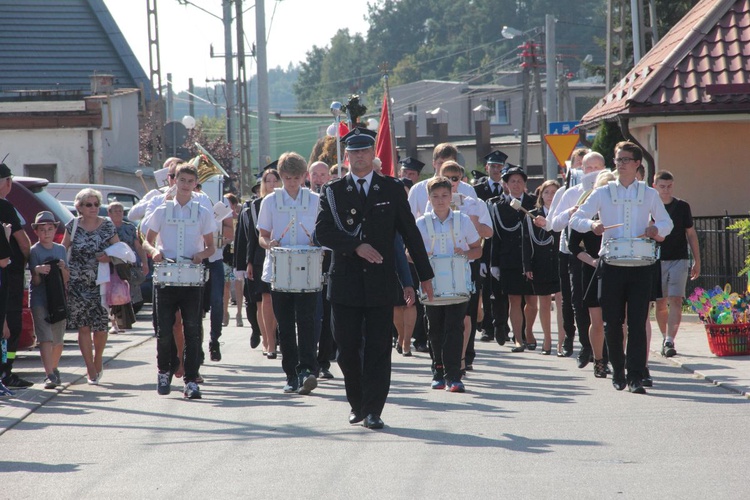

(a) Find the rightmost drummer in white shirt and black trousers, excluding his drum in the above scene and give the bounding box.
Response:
[570,141,673,394]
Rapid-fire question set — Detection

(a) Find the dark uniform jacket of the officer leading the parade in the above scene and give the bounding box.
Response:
[315,175,433,306]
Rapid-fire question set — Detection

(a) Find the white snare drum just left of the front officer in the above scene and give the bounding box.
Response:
[270,246,323,293]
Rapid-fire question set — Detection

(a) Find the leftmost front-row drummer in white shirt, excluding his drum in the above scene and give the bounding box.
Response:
[143,164,216,399]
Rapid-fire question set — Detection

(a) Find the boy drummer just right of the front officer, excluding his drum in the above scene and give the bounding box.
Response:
[417,178,482,392]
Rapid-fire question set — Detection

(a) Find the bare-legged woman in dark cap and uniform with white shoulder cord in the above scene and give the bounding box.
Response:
[487,167,536,352]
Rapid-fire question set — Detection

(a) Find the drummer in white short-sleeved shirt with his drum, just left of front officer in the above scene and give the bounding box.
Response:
[258,153,323,394]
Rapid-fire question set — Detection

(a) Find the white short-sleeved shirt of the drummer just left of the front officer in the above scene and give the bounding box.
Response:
[258,187,320,283]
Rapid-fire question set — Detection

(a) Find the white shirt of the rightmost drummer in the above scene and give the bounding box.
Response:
[570,179,674,255]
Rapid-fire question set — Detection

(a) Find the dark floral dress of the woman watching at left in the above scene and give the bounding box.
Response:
[65,219,117,332]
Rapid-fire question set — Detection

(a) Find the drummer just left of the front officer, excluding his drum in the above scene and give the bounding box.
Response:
[255,153,322,394]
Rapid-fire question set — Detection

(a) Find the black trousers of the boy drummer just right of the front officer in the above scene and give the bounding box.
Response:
[425,302,468,382]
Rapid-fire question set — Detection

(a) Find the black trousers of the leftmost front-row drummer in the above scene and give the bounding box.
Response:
[154,286,203,382]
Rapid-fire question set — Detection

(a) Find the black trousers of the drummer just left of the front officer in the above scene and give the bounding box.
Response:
[269,291,320,382]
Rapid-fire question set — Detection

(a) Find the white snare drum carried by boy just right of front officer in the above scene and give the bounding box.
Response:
[420,255,474,306]
